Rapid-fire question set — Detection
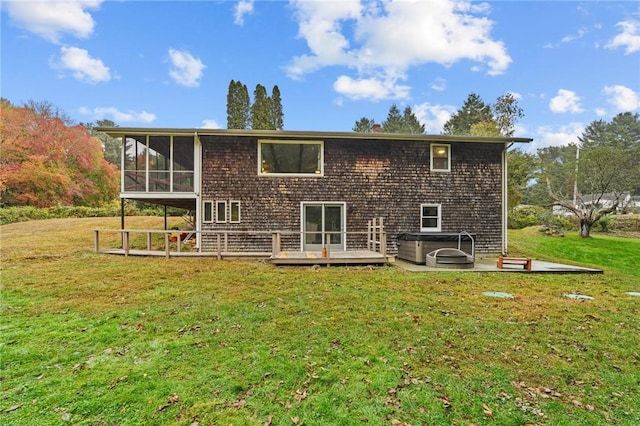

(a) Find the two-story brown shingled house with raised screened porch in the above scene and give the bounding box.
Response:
[99,127,531,260]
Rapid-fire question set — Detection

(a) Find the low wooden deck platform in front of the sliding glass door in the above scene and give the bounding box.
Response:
[271,250,391,265]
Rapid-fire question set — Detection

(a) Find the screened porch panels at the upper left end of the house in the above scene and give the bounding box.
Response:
[122,135,194,192]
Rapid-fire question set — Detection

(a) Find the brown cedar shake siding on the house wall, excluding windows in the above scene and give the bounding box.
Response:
[199,135,505,253]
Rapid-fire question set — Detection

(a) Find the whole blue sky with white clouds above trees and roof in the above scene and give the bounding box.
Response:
[0,0,640,151]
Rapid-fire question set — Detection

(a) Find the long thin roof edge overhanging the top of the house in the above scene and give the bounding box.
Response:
[95,127,533,143]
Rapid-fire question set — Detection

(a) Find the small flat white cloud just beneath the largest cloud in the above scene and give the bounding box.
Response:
[333,75,409,101]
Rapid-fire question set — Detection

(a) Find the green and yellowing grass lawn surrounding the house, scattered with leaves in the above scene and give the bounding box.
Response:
[0,218,640,426]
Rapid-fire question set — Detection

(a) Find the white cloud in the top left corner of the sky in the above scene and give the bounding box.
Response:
[2,0,103,43]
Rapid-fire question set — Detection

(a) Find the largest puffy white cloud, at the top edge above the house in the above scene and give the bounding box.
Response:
[287,0,511,99]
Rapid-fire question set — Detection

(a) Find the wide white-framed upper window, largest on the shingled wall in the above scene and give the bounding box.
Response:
[258,140,324,176]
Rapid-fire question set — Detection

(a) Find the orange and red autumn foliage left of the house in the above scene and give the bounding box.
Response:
[0,100,118,207]
